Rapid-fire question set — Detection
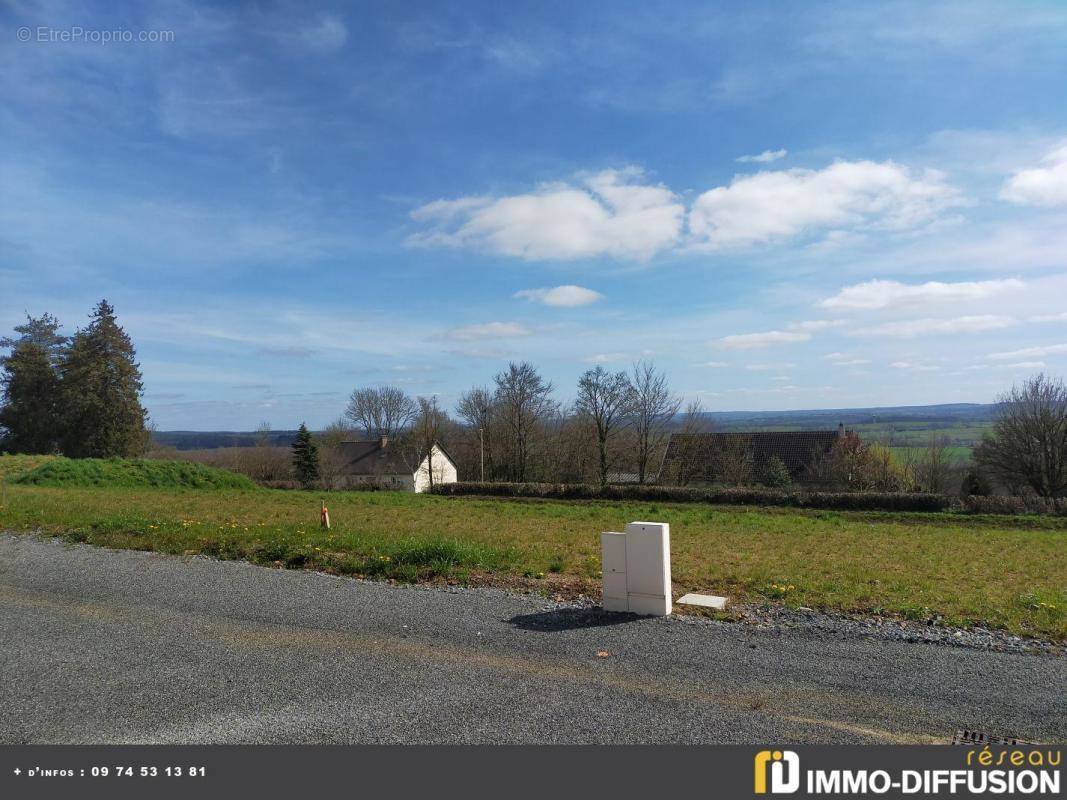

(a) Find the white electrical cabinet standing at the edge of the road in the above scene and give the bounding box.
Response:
[601,523,671,617]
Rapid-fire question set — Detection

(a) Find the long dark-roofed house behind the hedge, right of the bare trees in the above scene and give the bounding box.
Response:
[659,425,845,484]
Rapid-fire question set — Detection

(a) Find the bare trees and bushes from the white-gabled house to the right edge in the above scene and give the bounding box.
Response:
[325,362,1067,497]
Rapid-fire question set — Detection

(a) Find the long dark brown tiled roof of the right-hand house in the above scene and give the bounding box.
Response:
[660,430,841,481]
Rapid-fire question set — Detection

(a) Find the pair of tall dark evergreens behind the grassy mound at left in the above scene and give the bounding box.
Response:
[0,300,149,458]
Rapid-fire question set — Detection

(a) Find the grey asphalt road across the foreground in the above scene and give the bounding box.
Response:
[0,534,1067,743]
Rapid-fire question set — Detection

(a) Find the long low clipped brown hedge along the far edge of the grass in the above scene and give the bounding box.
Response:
[433,482,1067,514]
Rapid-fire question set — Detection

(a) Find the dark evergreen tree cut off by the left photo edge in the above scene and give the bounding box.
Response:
[0,314,67,453]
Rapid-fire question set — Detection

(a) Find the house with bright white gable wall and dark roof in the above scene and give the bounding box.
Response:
[337,436,458,492]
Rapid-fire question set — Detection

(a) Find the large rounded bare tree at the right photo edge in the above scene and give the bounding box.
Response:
[974,373,1067,497]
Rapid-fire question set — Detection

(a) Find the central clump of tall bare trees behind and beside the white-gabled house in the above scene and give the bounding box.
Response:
[320,362,682,484]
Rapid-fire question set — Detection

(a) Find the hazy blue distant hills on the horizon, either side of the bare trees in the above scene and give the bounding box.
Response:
[153,403,996,450]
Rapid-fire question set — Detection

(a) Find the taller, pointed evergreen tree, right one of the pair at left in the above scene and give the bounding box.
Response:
[60,300,148,458]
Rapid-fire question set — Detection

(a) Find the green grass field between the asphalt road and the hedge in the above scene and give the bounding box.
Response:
[0,459,1067,641]
